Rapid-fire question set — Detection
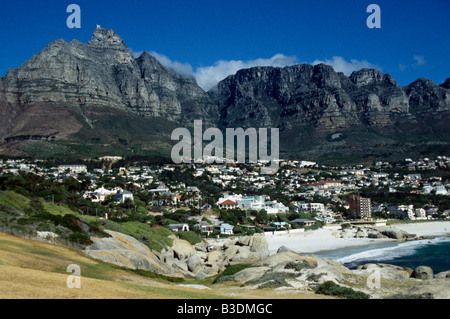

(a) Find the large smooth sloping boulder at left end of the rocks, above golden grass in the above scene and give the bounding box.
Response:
[84,230,182,277]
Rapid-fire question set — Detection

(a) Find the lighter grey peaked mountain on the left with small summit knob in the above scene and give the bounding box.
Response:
[0,27,218,158]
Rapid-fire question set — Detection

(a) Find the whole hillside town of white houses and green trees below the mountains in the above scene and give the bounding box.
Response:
[0,156,450,236]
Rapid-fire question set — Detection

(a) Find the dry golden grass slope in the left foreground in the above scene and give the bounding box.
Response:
[0,232,324,299]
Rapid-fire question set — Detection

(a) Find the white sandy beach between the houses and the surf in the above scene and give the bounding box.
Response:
[266,221,450,254]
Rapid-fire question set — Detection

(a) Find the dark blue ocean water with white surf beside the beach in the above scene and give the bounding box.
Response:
[316,237,450,274]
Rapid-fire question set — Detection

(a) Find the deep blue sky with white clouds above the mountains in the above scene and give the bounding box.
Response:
[0,0,450,89]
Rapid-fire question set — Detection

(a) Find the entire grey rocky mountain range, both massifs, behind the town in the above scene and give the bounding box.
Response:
[0,27,450,164]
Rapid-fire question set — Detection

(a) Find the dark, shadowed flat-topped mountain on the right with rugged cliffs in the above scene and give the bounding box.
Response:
[209,64,450,158]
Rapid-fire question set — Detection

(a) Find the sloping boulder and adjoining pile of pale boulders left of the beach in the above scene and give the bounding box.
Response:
[85,230,269,278]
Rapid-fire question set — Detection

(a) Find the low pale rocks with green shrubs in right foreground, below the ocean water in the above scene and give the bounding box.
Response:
[227,251,450,299]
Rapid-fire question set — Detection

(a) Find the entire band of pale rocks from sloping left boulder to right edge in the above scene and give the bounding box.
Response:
[85,231,450,298]
